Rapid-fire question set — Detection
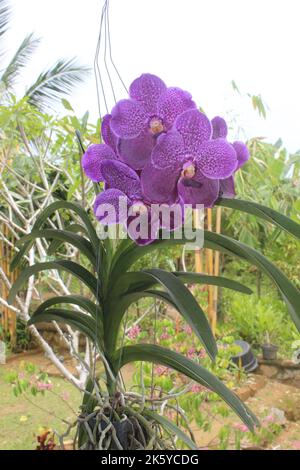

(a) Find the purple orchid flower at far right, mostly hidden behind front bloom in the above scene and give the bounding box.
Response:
[211,116,250,198]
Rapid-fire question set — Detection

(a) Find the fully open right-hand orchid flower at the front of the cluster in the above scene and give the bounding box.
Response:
[141,109,237,207]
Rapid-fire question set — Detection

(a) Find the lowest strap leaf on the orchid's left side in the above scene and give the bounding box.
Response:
[28,308,98,343]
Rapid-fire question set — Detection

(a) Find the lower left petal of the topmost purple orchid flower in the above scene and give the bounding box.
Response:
[118,129,156,170]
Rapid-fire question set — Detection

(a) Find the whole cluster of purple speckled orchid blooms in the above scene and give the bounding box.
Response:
[82,74,249,244]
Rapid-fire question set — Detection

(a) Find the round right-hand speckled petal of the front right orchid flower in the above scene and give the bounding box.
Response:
[197,139,237,179]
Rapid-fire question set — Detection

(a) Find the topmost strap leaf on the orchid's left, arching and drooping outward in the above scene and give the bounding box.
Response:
[10,201,99,271]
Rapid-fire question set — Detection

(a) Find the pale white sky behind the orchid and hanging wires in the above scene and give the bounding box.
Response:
[6,0,300,152]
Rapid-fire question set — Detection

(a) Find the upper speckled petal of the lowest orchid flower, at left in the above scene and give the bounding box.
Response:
[101,160,142,200]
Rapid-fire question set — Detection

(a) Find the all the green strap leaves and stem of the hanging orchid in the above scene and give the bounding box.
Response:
[9,194,300,448]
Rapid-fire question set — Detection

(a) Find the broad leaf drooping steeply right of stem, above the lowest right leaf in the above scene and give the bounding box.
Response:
[143,269,218,360]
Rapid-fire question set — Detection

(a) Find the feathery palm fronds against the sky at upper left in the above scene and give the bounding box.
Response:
[0,0,89,109]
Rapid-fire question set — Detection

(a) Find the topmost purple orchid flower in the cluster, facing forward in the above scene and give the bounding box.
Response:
[107,74,196,170]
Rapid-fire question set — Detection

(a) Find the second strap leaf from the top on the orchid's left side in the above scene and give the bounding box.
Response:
[17,229,96,266]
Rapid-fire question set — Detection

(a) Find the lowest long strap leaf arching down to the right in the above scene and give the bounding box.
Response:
[113,344,259,430]
